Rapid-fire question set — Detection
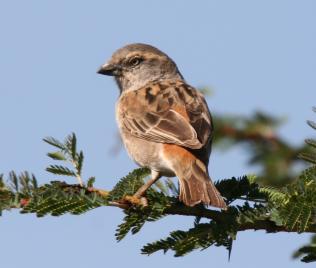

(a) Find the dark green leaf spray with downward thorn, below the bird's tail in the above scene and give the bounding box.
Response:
[142,202,267,257]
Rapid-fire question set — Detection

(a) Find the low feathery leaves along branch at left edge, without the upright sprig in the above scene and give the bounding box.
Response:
[0,172,107,217]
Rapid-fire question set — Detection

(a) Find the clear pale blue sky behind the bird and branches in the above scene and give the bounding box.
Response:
[0,0,316,268]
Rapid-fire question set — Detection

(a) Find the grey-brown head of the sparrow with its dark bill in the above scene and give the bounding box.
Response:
[98,44,183,92]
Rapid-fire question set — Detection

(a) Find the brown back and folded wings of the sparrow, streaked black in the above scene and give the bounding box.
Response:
[118,82,212,149]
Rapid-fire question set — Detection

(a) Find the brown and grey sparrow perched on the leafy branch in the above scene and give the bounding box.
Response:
[97,43,226,209]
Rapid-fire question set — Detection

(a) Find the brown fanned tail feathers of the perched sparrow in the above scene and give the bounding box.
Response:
[176,159,227,209]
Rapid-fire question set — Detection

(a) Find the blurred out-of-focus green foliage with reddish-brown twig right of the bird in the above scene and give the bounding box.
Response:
[214,112,313,185]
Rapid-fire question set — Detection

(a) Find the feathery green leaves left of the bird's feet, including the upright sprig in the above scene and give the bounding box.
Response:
[0,134,108,217]
